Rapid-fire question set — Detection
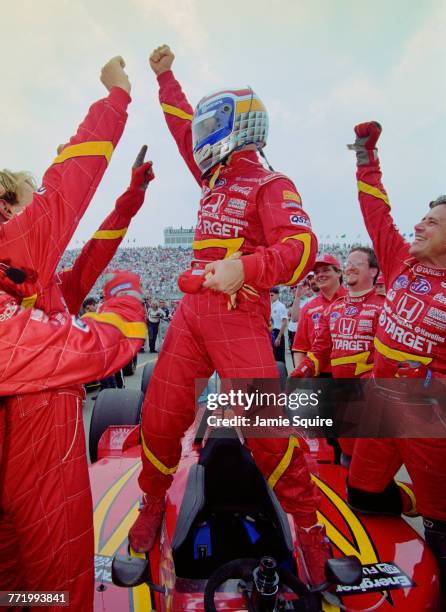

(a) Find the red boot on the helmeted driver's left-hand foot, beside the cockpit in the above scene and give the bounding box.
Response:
[129,493,166,552]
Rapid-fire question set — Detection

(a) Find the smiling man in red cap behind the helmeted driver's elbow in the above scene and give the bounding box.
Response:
[292,253,346,376]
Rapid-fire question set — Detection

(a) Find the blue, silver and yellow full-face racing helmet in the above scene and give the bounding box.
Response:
[192,87,268,174]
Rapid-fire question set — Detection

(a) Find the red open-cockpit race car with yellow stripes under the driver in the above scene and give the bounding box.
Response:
[90,364,440,612]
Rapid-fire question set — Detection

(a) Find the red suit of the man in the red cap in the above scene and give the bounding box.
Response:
[292,287,347,374]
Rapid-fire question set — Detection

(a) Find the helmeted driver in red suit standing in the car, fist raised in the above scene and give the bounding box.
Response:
[129,46,336,584]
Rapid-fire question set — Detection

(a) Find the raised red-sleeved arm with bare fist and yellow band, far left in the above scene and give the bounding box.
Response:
[0,57,130,291]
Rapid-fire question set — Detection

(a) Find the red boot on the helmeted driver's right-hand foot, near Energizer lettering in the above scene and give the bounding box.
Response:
[295,523,333,587]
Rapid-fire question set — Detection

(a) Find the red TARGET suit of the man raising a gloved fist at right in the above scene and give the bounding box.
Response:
[349,154,446,521]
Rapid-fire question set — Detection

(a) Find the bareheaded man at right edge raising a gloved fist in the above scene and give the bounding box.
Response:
[348,122,446,588]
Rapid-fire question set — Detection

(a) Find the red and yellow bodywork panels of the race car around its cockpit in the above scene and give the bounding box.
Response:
[90,426,439,612]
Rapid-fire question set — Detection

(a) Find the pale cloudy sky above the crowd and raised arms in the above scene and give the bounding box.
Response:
[0,0,446,246]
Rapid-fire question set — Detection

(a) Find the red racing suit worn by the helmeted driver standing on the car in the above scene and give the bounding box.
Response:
[139,71,317,524]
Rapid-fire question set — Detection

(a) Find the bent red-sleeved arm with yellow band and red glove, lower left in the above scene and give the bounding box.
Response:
[0,270,147,396]
